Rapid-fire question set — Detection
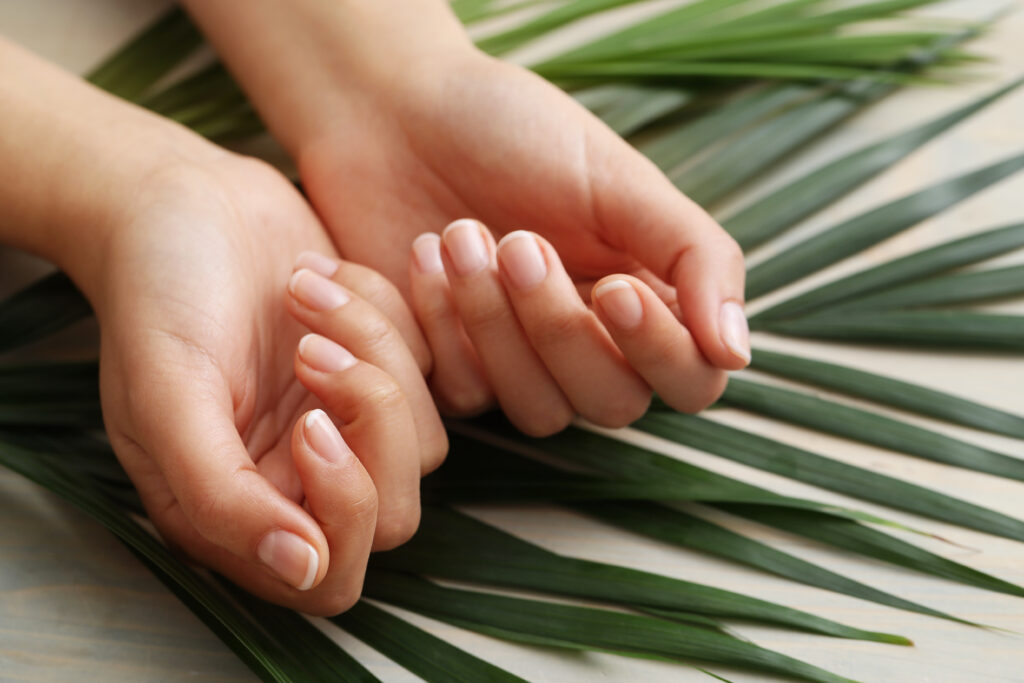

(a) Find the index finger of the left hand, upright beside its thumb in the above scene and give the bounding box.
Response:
[292,410,377,616]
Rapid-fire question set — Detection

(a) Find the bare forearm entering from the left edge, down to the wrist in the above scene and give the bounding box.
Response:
[0,39,222,284]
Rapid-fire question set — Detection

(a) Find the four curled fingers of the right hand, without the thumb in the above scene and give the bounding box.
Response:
[410,219,726,436]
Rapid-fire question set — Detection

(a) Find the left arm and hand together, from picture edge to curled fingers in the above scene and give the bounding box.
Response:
[0,37,447,614]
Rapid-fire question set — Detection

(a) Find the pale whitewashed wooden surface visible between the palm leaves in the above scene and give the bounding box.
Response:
[0,0,1024,683]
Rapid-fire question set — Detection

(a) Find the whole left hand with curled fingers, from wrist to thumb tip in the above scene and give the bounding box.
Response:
[95,154,446,614]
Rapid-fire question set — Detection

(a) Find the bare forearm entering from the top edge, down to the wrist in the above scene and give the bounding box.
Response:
[182,0,472,156]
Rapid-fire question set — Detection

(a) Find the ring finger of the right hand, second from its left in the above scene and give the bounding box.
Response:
[441,219,574,436]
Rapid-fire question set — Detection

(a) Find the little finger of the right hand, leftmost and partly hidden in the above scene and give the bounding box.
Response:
[409,232,495,417]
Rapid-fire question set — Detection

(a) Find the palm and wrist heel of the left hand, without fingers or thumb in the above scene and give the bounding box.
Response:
[100,161,330,518]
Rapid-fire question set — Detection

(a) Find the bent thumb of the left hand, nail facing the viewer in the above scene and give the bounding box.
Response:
[127,342,328,596]
